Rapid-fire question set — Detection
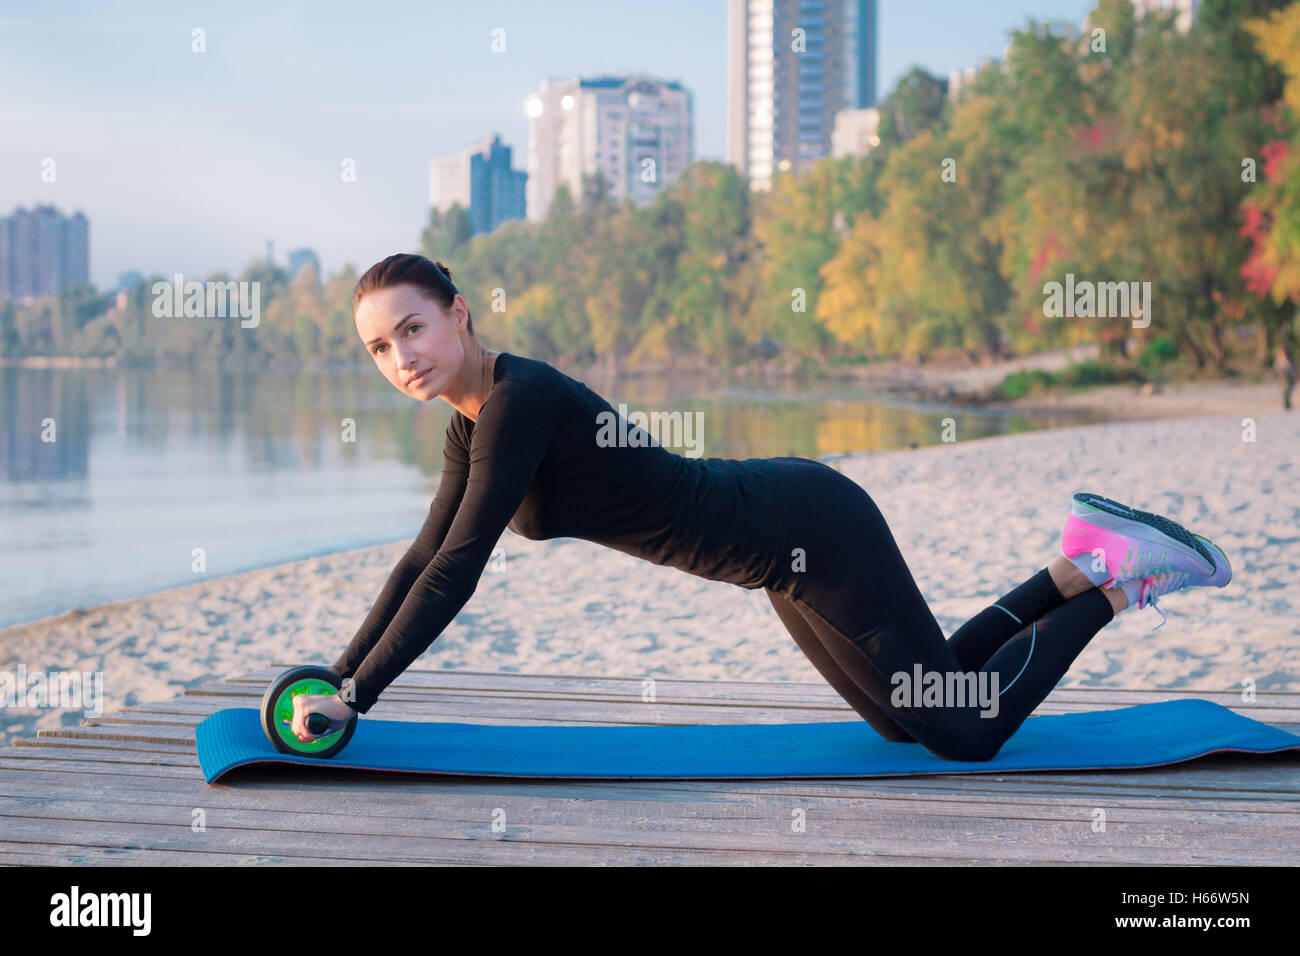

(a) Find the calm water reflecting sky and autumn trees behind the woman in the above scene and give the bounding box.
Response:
[0,367,1107,627]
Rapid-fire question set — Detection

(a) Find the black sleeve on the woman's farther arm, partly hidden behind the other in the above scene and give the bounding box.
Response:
[330,412,469,702]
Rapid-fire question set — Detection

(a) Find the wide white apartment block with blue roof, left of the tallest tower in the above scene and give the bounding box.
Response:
[525,74,694,221]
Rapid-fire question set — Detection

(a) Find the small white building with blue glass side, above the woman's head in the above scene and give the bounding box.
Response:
[429,134,528,235]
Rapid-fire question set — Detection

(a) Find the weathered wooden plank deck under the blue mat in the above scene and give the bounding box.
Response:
[0,661,1300,866]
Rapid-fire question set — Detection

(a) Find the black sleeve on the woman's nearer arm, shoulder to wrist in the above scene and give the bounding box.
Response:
[330,378,556,714]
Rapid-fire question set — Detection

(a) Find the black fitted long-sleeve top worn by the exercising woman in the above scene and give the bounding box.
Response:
[332,352,787,714]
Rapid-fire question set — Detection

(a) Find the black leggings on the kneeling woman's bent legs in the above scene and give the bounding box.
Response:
[764,458,1114,761]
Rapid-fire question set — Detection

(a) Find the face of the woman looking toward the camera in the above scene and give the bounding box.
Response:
[356,285,469,402]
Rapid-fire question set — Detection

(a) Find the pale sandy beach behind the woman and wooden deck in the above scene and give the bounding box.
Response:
[0,392,1300,744]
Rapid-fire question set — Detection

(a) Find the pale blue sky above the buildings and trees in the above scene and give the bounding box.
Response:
[0,0,1093,287]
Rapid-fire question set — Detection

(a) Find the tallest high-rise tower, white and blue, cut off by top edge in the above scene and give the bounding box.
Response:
[727,0,878,189]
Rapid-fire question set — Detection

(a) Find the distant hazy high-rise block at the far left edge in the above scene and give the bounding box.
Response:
[0,206,90,299]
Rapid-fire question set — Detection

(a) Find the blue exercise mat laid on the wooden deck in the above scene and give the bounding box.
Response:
[195,698,1300,783]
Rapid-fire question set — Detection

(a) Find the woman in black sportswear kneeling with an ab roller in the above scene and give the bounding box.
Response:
[293,255,1231,761]
